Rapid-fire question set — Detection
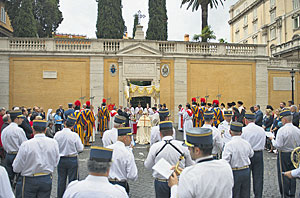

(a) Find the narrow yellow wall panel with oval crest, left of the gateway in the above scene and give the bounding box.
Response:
[103,59,119,106]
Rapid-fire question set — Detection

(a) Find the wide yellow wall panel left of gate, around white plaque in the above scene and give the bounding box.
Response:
[9,57,90,111]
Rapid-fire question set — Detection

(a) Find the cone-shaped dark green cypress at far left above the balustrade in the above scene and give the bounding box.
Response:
[13,0,37,37]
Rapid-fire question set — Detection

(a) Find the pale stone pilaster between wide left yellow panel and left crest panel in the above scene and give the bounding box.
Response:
[90,57,104,110]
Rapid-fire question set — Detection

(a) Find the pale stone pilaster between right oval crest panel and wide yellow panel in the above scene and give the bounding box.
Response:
[174,58,187,123]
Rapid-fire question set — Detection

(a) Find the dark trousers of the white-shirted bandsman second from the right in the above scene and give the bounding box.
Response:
[250,151,264,198]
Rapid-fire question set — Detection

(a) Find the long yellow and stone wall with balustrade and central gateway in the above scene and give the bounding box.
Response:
[0,38,300,122]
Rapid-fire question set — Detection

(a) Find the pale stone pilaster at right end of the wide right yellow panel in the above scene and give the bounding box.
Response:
[256,60,268,109]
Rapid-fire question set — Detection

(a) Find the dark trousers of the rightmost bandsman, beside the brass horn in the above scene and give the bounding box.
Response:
[277,151,296,197]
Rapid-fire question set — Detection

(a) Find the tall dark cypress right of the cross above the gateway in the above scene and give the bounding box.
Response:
[146,0,168,41]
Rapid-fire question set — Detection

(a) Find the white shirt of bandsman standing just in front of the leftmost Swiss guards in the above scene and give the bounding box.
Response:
[54,128,83,156]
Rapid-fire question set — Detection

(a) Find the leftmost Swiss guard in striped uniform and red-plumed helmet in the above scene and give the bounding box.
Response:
[73,100,87,144]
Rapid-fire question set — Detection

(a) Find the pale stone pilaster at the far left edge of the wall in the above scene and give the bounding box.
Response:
[0,55,9,109]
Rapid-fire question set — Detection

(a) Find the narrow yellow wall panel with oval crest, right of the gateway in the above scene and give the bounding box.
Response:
[160,60,175,121]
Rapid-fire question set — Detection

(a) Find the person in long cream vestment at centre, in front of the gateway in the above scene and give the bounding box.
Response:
[135,111,151,144]
